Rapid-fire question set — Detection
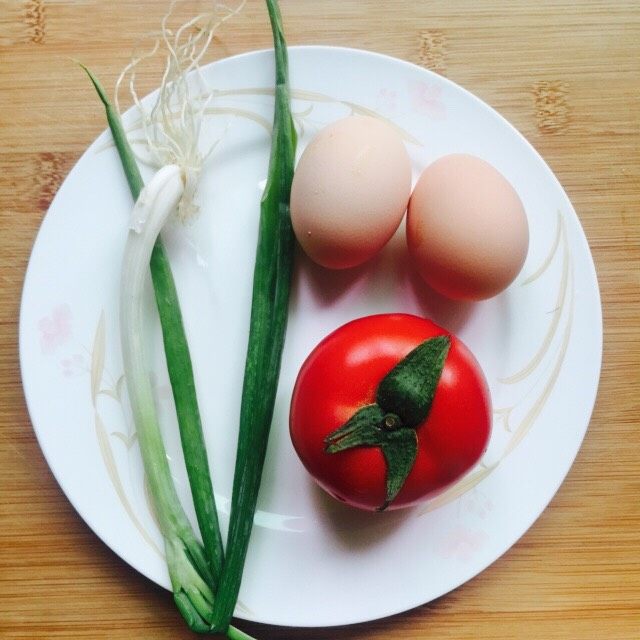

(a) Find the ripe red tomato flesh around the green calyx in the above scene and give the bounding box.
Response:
[290,314,491,510]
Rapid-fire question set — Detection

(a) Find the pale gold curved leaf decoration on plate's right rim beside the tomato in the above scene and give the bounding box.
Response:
[418,211,575,516]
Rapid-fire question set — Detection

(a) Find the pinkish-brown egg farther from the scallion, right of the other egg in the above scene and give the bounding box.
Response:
[407,154,529,300]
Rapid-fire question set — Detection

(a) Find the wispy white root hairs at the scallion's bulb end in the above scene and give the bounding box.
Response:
[114,0,246,221]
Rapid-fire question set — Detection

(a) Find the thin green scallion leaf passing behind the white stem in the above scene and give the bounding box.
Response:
[81,65,224,590]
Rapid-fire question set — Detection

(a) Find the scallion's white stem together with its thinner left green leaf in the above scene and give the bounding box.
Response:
[83,66,251,640]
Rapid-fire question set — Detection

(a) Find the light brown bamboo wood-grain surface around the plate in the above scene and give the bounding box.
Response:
[0,0,640,640]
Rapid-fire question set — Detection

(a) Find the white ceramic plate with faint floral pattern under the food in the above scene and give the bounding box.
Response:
[20,47,602,626]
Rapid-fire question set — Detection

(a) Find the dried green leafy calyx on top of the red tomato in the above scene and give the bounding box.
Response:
[324,335,451,511]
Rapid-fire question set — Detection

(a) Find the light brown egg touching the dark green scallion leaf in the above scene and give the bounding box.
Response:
[291,116,411,269]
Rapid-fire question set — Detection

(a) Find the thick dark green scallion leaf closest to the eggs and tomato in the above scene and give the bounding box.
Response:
[212,0,297,633]
